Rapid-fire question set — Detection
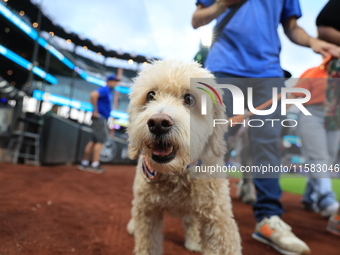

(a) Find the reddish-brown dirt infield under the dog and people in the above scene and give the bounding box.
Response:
[0,164,340,255]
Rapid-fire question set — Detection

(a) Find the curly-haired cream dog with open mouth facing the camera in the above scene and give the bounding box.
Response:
[127,60,241,255]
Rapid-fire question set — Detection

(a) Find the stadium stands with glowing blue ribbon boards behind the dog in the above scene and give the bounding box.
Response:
[0,0,133,121]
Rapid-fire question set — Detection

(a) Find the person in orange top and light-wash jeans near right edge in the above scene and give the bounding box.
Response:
[289,59,340,217]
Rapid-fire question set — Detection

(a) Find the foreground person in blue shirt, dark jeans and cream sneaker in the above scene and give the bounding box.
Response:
[192,0,340,255]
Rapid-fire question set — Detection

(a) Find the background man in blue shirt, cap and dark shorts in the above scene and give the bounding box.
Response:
[78,75,119,173]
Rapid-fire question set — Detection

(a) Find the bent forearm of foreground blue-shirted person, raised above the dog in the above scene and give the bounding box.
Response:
[191,0,241,29]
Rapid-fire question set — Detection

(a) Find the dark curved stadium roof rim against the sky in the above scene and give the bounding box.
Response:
[6,0,157,63]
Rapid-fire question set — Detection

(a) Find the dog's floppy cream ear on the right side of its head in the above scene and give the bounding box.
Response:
[209,99,228,157]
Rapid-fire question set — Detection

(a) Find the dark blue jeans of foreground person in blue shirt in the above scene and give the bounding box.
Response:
[214,73,285,222]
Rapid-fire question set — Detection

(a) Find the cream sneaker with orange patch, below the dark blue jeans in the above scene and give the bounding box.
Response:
[252,216,311,255]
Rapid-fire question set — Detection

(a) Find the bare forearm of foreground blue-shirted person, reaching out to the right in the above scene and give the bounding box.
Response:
[283,16,340,58]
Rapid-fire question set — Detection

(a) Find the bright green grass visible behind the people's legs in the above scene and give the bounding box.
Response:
[229,172,340,200]
